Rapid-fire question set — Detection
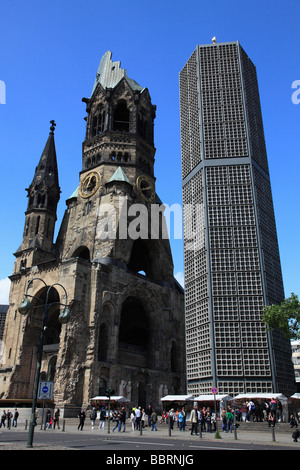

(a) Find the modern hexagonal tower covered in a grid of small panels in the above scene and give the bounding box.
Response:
[180,42,295,396]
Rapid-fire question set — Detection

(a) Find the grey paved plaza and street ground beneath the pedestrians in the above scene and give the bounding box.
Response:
[0,420,300,451]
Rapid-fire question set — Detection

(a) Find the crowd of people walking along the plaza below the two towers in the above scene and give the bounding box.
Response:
[0,398,300,434]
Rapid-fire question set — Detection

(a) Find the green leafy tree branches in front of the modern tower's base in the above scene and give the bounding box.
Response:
[263,293,300,339]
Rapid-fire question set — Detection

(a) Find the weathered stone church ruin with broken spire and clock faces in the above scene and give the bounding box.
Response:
[0,53,186,413]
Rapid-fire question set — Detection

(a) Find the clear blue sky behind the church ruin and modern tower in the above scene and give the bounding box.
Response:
[0,0,300,303]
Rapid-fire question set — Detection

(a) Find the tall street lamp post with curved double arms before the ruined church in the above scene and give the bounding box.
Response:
[18,278,70,447]
